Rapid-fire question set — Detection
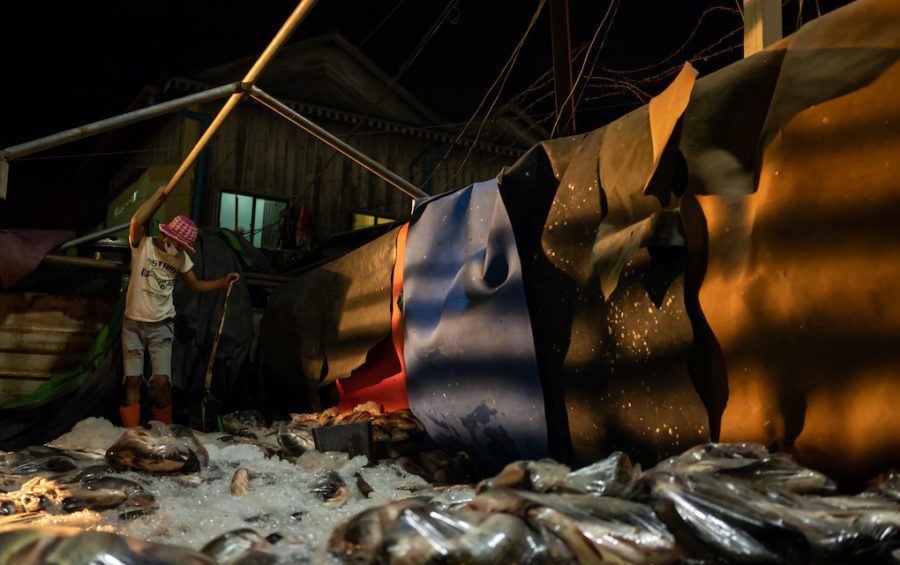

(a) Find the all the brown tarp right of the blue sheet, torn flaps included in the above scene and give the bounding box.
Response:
[501,0,900,484]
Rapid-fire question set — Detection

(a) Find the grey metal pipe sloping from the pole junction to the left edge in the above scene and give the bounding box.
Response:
[0,82,241,161]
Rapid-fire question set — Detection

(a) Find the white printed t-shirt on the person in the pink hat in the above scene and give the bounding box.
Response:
[125,237,194,322]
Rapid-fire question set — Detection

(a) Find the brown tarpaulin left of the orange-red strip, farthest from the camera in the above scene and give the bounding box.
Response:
[259,228,399,412]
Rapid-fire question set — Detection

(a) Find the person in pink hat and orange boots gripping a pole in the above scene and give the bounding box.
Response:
[119,187,240,427]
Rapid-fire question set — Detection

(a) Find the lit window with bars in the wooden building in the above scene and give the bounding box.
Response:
[219,192,287,249]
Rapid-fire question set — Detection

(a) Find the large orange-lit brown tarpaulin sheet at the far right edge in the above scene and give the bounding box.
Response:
[679,0,900,486]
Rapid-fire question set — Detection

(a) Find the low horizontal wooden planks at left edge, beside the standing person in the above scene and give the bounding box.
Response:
[0,292,115,404]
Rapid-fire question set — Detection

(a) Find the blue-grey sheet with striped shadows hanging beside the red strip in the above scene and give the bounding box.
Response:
[403,181,547,472]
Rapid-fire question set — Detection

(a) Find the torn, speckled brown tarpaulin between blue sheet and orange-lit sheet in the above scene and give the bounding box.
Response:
[501,66,709,470]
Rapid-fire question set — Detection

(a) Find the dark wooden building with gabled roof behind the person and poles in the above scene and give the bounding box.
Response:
[92,33,547,249]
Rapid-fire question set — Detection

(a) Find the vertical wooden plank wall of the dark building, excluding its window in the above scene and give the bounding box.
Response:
[112,102,524,241]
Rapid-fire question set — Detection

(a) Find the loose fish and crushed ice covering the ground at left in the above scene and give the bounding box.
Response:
[0,411,464,563]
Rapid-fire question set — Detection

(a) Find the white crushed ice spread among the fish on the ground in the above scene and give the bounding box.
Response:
[47,418,440,563]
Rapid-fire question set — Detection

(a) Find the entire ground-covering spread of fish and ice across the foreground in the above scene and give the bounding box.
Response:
[0,408,900,564]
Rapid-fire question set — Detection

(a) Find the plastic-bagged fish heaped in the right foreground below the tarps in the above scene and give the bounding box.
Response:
[328,444,900,563]
